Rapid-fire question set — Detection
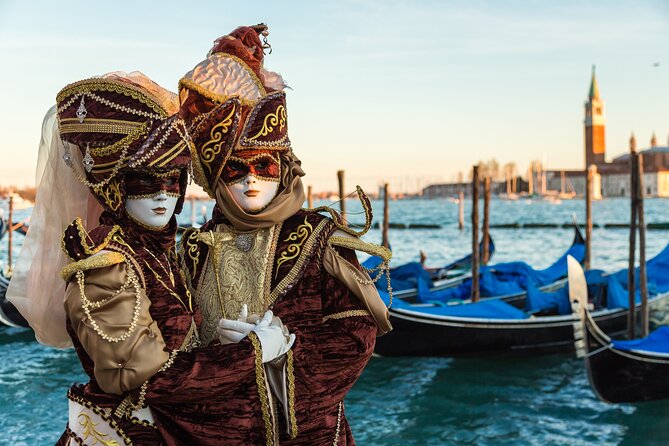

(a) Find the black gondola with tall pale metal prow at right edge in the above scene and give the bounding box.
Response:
[569,256,669,403]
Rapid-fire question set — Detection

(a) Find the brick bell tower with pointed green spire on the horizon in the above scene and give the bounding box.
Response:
[583,65,606,169]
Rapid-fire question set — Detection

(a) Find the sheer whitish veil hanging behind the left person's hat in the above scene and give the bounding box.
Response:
[7,105,102,348]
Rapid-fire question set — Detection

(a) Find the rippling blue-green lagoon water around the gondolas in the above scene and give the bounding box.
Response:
[0,199,669,446]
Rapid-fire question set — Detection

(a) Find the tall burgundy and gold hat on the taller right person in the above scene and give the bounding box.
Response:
[179,24,290,197]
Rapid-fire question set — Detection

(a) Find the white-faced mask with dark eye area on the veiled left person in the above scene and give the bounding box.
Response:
[125,171,181,229]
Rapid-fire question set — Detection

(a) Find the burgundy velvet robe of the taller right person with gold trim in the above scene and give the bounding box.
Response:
[176,210,377,445]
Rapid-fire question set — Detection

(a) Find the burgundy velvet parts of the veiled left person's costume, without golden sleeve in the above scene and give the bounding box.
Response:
[58,216,264,445]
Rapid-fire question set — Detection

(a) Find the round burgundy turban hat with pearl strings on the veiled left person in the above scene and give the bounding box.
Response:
[56,72,190,214]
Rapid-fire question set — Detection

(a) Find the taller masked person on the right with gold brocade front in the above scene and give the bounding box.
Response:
[179,25,391,445]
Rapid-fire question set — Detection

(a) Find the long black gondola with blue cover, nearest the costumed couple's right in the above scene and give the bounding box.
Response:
[375,248,669,356]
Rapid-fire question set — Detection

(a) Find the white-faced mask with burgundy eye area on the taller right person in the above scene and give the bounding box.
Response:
[221,150,281,212]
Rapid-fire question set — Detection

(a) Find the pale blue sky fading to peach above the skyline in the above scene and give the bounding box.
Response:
[0,0,669,192]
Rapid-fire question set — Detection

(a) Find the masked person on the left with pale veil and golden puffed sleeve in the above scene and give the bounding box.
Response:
[5,72,293,445]
